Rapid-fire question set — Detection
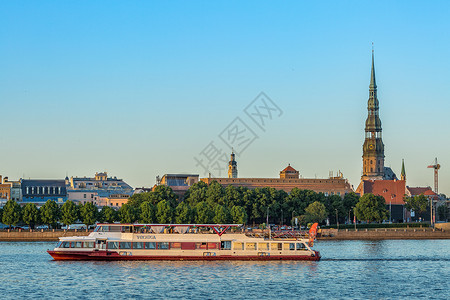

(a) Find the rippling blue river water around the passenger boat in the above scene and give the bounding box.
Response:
[0,240,450,299]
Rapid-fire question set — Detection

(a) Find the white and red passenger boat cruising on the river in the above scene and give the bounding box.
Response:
[47,223,320,261]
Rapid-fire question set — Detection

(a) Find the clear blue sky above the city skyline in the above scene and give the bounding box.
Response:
[0,0,450,195]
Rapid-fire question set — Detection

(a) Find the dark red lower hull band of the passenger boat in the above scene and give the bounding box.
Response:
[47,250,320,261]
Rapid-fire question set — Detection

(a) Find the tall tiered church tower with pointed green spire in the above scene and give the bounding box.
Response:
[361,49,384,180]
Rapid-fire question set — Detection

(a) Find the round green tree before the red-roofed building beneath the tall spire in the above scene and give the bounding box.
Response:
[355,193,388,223]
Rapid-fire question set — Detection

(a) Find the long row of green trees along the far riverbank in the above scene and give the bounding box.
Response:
[5,182,440,227]
